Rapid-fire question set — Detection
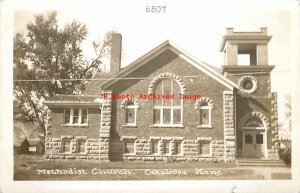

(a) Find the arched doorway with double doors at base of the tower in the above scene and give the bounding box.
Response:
[240,112,268,158]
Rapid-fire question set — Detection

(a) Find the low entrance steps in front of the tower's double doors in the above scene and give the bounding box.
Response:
[236,158,285,167]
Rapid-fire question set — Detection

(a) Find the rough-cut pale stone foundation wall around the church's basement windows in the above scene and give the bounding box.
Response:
[45,137,224,162]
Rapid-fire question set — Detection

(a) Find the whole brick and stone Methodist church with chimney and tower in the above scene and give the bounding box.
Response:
[45,28,278,162]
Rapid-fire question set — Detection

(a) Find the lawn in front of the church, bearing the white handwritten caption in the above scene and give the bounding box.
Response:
[14,155,263,180]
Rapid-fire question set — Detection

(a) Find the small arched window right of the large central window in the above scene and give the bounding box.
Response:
[195,97,214,128]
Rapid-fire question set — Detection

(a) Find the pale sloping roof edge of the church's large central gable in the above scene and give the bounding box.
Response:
[102,40,238,90]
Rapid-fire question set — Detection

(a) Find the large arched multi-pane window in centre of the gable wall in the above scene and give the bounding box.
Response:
[153,78,183,126]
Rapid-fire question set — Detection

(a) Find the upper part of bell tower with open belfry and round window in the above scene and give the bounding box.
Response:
[220,28,274,96]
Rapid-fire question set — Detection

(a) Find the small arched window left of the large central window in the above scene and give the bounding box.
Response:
[121,99,139,126]
